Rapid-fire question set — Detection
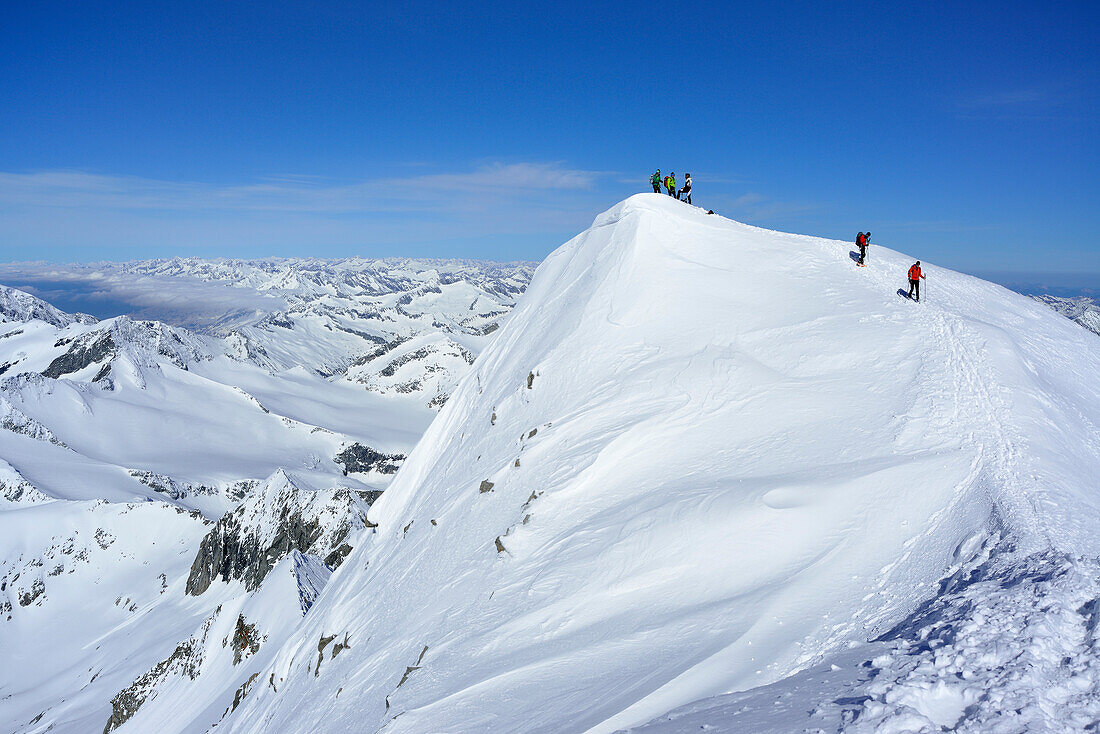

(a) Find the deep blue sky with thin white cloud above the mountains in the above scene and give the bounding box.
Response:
[0,1,1100,277]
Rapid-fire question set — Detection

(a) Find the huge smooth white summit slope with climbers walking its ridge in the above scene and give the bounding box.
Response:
[218,195,1100,732]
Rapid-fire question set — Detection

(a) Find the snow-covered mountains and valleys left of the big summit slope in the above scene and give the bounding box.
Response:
[0,261,525,733]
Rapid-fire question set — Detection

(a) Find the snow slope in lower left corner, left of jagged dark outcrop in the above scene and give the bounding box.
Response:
[0,501,220,733]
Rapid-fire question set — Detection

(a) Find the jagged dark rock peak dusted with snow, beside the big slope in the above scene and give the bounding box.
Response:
[187,470,381,595]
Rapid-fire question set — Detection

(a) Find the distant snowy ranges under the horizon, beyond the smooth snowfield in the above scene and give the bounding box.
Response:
[0,258,535,408]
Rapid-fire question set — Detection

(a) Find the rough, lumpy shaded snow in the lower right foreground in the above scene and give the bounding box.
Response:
[628,521,1100,734]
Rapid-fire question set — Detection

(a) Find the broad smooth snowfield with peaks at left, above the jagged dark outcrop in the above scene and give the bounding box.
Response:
[0,316,411,519]
